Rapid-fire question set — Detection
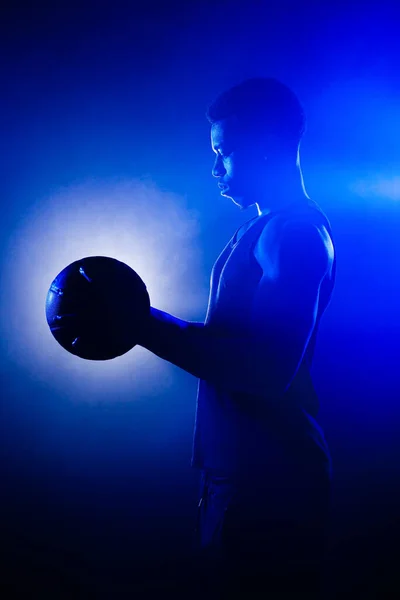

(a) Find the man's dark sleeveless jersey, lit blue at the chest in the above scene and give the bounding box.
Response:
[192,200,336,476]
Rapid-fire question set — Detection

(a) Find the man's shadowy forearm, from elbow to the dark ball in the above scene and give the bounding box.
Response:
[139,308,286,395]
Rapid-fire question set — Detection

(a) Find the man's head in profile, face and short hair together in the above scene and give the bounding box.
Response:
[207,78,305,208]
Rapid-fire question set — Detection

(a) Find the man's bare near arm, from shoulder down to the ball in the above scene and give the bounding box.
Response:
[139,218,331,397]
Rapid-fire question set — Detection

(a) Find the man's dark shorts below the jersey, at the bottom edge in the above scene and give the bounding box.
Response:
[195,472,330,600]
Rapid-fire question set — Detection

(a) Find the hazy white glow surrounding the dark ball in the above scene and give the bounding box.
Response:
[1,180,206,401]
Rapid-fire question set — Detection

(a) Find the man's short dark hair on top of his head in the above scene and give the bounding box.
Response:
[206,77,306,146]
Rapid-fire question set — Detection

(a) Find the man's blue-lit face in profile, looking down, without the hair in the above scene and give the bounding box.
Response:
[211,117,266,209]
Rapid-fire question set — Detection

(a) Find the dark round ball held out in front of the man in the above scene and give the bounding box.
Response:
[45,256,150,360]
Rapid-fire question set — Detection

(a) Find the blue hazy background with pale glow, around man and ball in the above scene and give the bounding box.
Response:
[0,0,400,598]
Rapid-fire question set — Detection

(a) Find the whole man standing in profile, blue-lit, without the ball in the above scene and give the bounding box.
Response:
[140,78,336,598]
